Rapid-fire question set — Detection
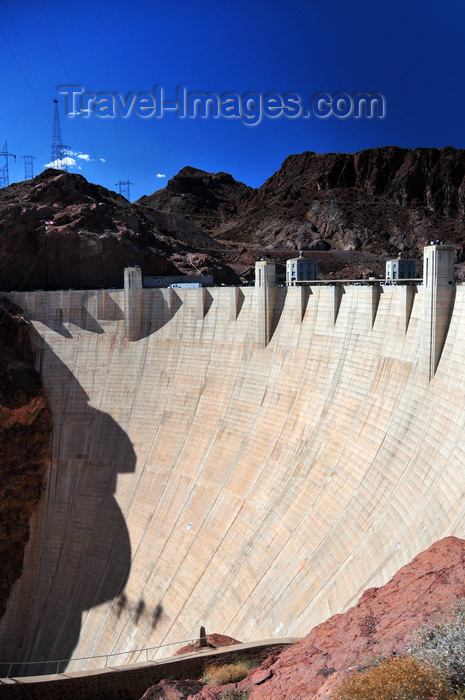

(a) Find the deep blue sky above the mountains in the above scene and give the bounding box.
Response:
[0,0,465,200]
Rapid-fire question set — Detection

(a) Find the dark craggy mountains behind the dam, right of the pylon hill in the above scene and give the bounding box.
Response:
[140,146,465,262]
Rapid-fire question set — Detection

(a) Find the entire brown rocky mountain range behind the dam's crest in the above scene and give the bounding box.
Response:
[0,146,465,290]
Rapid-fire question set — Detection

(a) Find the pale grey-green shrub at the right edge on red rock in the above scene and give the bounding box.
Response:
[407,598,465,688]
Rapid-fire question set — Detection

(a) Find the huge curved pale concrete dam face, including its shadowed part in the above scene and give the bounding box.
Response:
[0,247,465,673]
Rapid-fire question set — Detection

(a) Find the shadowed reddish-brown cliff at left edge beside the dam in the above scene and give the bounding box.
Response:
[0,299,52,617]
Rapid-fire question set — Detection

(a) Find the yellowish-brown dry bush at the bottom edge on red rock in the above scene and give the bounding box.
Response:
[334,656,456,700]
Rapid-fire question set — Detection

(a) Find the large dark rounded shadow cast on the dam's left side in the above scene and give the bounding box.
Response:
[0,336,136,675]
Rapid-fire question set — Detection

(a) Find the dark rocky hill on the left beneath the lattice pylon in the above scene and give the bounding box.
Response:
[0,169,237,290]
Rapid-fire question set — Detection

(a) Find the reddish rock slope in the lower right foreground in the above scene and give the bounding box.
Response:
[189,537,465,700]
